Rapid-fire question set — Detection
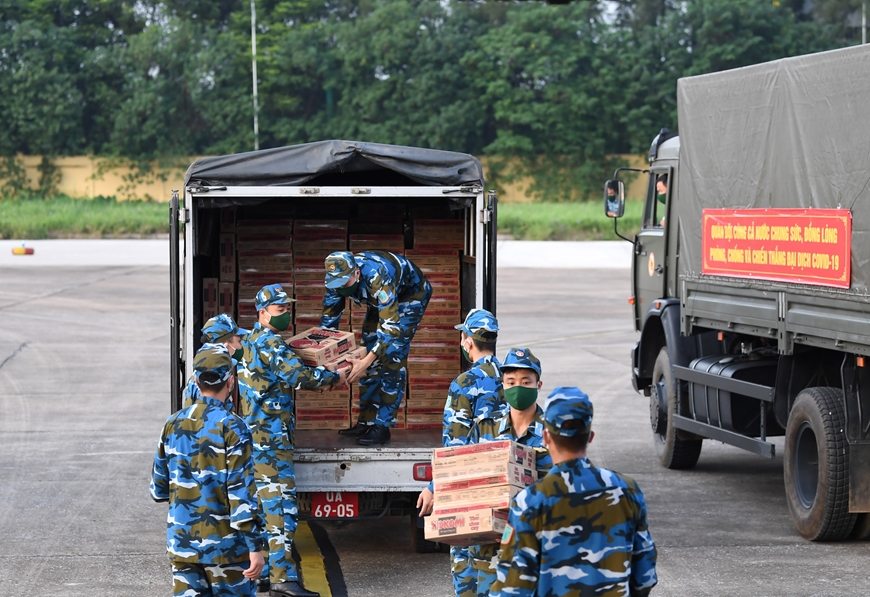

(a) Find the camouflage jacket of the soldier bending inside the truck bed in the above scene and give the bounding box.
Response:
[320,251,426,358]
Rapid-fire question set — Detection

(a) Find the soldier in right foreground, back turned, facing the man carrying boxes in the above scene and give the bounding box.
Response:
[492,388,657,597]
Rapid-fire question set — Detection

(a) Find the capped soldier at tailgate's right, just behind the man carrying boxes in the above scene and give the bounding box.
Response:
[417,309,505,597]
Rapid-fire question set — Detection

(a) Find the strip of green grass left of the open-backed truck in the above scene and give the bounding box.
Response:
[0,196,169,239]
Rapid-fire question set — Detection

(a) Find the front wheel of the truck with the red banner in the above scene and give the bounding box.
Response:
[650,347,703,469]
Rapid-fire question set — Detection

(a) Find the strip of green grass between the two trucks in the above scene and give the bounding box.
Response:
[498,201,643,240]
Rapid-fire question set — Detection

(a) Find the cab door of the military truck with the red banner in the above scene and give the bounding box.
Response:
[632,167,673,330]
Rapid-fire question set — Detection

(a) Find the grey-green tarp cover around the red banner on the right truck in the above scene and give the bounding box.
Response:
[671,46,870,300]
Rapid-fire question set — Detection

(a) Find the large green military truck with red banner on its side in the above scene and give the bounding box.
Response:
[605,46,870,541]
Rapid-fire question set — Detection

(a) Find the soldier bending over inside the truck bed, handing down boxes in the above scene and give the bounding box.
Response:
[320,251,432,445]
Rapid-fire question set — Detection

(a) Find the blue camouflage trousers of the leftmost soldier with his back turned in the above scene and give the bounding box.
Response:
[172,562,257,597]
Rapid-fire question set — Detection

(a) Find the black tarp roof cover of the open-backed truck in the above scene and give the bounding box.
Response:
[184,141,483,187]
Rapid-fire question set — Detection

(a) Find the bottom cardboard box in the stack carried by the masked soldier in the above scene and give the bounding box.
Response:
[423,508,507,547]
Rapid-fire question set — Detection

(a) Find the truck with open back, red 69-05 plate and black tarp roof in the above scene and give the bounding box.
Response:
[170,141,496,551]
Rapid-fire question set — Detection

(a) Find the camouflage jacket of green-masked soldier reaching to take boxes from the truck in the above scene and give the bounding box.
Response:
[238,322,339,450]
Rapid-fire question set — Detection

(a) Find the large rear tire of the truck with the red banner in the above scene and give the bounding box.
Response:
[783,388,856,541]
